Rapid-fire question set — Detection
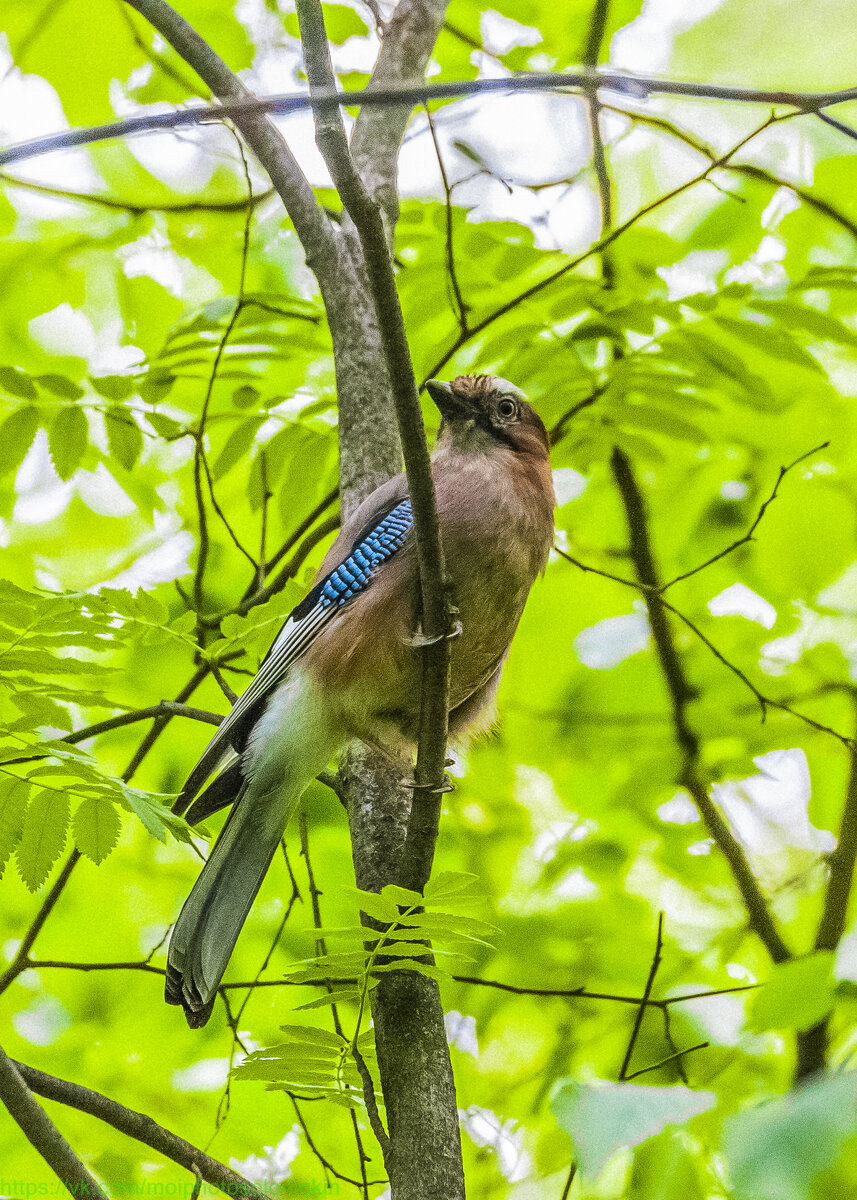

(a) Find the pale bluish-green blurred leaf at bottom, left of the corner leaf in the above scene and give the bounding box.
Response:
[551,1079,717,1178]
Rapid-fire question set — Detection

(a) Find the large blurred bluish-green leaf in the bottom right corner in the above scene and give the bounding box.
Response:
[724,1072,857,1200]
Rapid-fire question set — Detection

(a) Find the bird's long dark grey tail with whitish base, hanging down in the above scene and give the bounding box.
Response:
[166,680,337,1028]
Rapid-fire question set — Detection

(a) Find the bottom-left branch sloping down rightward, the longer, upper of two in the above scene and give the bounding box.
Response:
[10,1060,264,1200]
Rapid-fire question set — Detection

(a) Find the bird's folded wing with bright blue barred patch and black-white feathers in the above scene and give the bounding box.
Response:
[173,498,413,812]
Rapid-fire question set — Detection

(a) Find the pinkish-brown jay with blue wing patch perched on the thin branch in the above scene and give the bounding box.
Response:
[166,374,556,1028]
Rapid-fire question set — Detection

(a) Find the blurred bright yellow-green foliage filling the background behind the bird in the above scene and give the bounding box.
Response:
[0,0,857,1200]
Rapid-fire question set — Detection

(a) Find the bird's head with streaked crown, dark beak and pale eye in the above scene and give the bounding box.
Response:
[425,376,549,458]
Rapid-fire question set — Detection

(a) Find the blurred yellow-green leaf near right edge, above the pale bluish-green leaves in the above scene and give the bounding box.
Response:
[747,950,835,1033]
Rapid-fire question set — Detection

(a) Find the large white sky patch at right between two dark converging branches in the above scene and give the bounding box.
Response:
[712,749,837,857]
